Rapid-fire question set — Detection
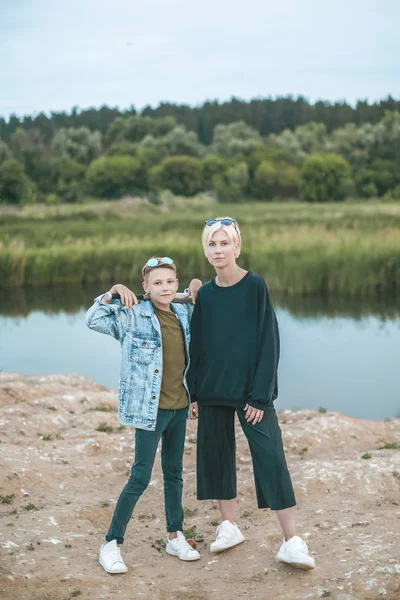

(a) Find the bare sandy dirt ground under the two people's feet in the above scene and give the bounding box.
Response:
[0,373,400,600]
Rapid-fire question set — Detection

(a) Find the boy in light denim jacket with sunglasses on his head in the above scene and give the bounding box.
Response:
[86,257,201,573]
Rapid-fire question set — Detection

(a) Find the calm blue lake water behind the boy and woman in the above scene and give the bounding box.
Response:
[0,282,400,419]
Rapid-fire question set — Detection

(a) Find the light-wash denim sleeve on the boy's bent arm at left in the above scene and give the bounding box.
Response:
[85,294,132,342]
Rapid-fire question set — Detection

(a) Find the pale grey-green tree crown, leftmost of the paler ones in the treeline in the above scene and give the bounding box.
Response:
[51,127,102,164]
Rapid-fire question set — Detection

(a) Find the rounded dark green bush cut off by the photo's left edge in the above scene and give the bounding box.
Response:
[0,158,35,204]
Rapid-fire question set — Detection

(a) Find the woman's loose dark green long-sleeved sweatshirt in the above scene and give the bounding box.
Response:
[187,272,279,409]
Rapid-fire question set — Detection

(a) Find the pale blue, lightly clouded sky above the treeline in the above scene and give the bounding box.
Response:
[0,0,400,118]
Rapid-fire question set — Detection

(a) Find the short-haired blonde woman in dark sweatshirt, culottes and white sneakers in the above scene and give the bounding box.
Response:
[188,217,315,569]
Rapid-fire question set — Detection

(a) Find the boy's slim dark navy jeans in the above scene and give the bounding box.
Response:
[106,408,188,544]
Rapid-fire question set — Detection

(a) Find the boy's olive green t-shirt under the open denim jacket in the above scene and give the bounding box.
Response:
[153,304,188,410]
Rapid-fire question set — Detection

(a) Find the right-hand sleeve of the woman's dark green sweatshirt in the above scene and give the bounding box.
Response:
[248,282,279,410]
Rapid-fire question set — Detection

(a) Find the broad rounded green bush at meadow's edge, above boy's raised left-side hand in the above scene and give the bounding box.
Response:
[85,156,142,199]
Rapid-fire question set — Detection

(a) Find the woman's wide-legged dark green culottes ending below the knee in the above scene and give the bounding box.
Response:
[197,406,296,510]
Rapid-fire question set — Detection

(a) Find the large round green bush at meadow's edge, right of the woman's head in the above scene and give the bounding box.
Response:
[300,154,352,202]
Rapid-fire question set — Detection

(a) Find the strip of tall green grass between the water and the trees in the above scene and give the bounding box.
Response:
[0,197,400,295]
